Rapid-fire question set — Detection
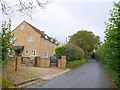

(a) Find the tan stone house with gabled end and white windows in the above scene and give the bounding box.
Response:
[12,21,58,58]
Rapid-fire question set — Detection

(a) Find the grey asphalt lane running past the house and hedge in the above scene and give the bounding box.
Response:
[26,60,110,88]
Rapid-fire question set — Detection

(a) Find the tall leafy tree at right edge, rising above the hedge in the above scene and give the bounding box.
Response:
[105,3,120,71]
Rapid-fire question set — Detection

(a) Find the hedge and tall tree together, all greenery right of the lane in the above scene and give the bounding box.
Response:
[96,3,120,88]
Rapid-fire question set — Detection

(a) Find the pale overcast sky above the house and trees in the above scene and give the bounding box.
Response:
[1,0,119,44]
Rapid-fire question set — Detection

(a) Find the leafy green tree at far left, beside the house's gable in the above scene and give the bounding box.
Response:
[0,20,13,62]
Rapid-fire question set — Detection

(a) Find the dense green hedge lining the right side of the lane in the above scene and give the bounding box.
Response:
[95,42,120,88]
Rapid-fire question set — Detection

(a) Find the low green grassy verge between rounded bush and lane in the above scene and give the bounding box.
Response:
[66,59,86,68]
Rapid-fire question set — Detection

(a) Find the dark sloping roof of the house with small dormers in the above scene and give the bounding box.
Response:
[13,21,58,45]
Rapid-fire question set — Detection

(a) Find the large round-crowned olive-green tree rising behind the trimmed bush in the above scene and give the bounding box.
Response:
[68,30,100,56]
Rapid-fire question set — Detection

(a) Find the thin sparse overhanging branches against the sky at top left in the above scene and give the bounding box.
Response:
[0,0,52,18]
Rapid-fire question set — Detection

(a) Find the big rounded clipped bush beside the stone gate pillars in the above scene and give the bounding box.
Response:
[55,44,84,61]
